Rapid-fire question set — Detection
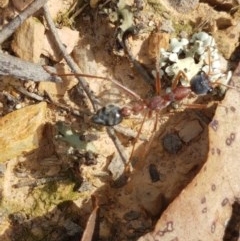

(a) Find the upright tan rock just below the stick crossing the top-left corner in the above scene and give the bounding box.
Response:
[12,17,45,63]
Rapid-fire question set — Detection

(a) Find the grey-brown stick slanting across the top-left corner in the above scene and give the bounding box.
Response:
[0,0,47,44]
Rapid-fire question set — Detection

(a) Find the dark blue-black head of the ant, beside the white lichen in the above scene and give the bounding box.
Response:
[190,71,213,95]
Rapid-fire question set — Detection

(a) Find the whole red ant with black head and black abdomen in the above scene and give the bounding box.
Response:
[44,33,234,165]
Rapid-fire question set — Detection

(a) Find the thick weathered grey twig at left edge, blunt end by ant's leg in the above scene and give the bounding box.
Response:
[0,53,61,82]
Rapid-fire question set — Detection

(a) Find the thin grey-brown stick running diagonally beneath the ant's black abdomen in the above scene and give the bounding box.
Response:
[43,4,127,163]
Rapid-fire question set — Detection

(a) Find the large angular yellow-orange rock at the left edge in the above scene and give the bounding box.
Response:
[0,102,47,162]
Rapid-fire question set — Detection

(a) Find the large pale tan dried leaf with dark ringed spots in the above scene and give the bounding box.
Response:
[139,68,240,241]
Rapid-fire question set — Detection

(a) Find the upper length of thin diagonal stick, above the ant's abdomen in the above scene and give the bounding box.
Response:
[43,4,98,111]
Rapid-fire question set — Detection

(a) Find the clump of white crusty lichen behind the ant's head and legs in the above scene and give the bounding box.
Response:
[156,32,231,87]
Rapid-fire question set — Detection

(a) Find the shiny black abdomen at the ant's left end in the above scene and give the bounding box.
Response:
[92,105,123,126]
